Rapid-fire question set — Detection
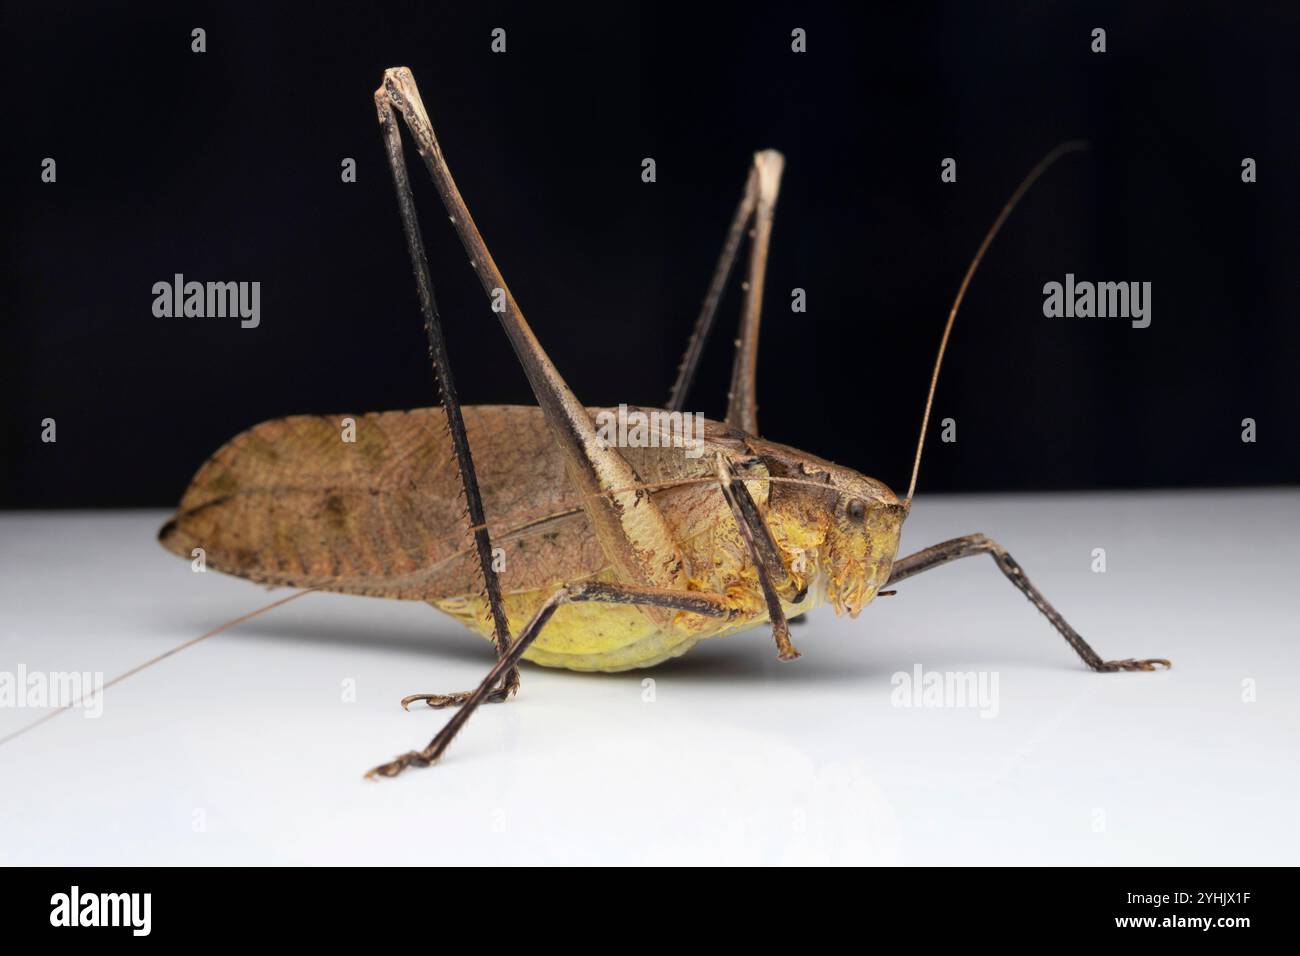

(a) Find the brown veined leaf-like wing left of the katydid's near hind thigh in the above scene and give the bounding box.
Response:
[159,406,603,600]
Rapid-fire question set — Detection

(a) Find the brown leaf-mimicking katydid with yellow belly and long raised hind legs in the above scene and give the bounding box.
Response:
[5,68,1169,777]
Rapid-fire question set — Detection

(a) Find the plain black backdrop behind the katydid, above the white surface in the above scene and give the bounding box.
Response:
[0,1,1300,507]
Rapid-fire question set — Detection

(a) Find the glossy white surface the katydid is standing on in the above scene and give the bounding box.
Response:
[0,490,1300,866]
